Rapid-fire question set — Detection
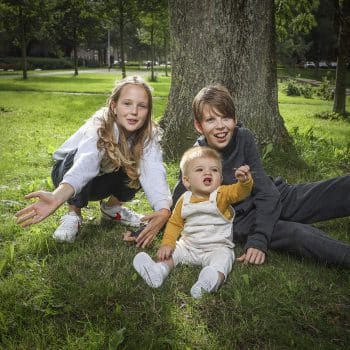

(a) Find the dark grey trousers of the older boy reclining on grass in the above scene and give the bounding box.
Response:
[233,176,350,267]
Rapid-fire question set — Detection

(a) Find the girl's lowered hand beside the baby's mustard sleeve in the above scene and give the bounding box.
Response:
[136,209,171,248]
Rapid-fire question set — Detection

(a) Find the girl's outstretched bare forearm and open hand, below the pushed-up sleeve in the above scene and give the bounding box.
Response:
[15,183,74,227]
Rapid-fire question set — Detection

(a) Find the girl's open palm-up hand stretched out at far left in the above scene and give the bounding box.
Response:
[15,191,61,227]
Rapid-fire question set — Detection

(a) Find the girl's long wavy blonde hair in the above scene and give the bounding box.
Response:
[97,76,154,188]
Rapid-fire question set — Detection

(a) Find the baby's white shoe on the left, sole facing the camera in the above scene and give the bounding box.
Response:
[133,252,167,288]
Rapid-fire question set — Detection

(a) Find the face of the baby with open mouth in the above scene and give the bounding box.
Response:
[182,157,222,197]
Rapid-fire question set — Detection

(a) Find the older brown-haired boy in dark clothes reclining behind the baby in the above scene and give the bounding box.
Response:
[173,85,350,268]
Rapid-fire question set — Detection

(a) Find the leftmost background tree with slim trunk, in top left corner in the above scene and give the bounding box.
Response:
[0,0,54,79]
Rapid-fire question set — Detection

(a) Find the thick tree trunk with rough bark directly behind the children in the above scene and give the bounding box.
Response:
[161,0,289,159]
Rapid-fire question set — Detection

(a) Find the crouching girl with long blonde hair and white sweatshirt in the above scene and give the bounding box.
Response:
[16,76,171,247]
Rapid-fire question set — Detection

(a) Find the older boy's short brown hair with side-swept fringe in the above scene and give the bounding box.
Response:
[192,85,236,122]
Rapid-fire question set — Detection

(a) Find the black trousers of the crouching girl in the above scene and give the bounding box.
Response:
[51,151,138,208]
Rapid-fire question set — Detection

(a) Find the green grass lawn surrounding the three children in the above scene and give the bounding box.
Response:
[0,69,350,350]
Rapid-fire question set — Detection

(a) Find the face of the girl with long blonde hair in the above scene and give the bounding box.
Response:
[111,84,149,136]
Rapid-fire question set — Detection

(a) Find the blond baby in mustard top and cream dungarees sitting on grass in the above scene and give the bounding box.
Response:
[133,147,253,298]
